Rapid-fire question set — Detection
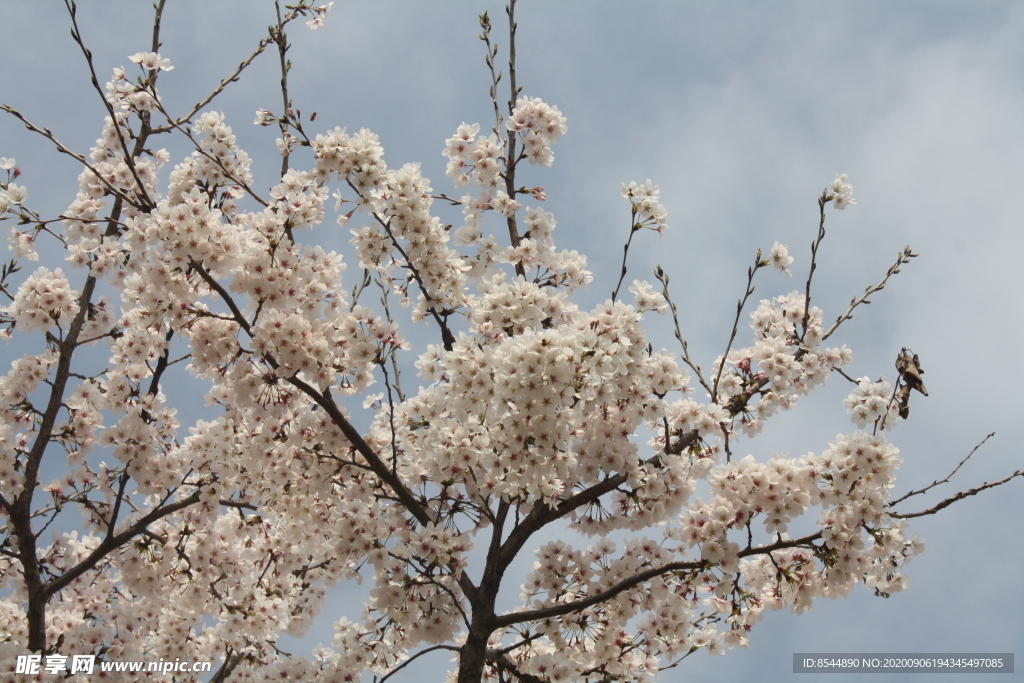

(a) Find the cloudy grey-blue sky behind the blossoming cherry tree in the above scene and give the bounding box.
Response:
[0,0,1024,683]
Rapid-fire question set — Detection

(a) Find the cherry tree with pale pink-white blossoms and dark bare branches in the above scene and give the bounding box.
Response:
[0,0,1024,683]
